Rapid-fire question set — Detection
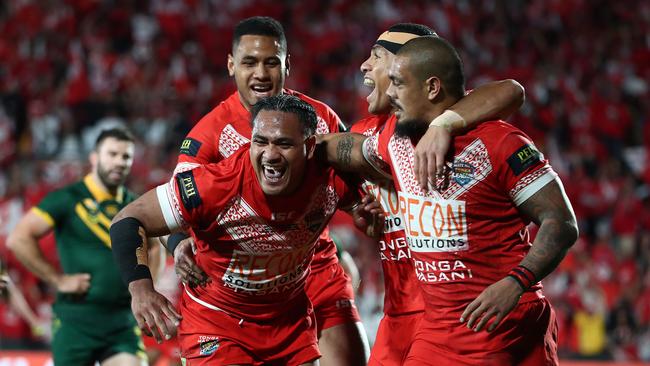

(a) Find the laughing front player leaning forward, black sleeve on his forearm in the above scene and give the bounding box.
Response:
[111,94,379,365]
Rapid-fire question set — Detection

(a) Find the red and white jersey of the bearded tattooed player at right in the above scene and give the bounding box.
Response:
[363,119,558,325]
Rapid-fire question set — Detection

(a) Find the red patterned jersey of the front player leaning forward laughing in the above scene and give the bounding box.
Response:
[157,145,358,320]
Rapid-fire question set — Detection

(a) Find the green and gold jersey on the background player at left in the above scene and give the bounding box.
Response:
[32,175,135,309]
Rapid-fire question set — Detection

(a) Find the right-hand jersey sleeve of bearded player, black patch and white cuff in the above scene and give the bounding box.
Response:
[495,131,559,206]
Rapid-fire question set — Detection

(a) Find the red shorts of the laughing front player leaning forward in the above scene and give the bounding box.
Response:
[178,292,320,366]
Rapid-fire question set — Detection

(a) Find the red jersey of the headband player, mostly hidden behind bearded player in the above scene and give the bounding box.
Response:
[350,115,424,316]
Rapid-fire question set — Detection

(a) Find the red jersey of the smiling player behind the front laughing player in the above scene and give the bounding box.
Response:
[176,89,341,271]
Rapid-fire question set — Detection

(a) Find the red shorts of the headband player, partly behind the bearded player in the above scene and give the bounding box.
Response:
[368,311,424,366]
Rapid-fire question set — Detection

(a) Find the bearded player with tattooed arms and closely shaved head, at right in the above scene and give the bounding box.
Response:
[323,37,577,366]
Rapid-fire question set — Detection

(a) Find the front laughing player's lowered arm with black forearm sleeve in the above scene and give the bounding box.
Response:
[110,189,181,343]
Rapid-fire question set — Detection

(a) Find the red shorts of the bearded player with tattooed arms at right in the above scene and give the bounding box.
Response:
[404,298,559,366]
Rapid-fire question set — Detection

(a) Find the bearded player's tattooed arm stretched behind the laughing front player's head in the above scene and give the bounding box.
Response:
[316,133,390,181]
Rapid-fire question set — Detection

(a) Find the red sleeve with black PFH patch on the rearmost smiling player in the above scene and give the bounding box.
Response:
[174,111,221,173]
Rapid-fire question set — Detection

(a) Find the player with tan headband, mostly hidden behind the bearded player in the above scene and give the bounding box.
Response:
[352,23,523,366]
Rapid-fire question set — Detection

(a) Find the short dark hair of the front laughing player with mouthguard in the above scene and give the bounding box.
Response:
[251,93,318,137]
